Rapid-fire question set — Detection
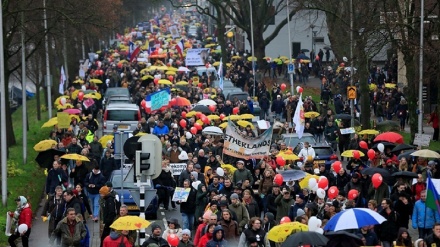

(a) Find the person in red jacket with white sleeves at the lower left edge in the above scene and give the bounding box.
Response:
[8,196,32,247]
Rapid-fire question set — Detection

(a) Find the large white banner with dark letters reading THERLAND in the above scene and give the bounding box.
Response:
[223,121,273,159]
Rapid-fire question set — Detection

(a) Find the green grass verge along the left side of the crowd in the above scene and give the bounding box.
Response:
[0,94,49,246]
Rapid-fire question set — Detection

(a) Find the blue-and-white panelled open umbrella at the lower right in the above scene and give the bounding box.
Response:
[324,208,386,231]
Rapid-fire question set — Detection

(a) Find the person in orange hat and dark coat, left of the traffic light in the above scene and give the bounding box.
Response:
[99,186,119,247]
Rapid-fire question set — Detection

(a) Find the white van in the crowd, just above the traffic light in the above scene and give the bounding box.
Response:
[103,103,141,134]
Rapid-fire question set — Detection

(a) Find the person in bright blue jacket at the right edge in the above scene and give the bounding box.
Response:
[411,190,440,238]
